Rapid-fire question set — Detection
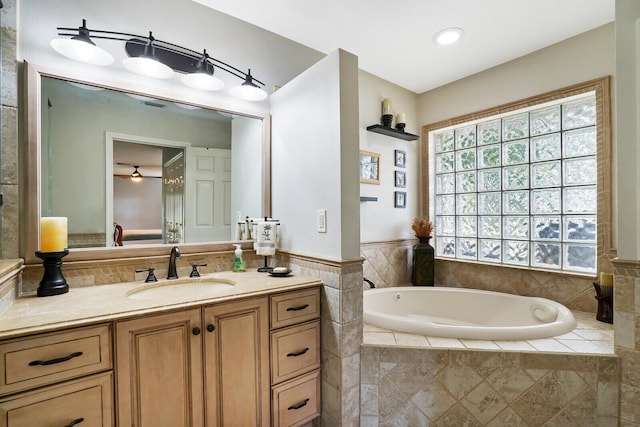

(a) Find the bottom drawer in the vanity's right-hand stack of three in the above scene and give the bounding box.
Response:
[271,370,320,427]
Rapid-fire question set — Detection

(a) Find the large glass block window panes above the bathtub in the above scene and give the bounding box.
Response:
[430,93,597,273]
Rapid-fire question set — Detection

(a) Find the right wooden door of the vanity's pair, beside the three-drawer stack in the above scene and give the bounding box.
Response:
[204,297,270,427]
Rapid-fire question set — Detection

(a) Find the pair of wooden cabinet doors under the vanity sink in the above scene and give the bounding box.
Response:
[116,297,270,426]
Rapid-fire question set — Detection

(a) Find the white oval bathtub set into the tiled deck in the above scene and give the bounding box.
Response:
[363,286,577,340]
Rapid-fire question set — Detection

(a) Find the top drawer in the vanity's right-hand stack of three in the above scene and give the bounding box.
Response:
[271,288,320,329]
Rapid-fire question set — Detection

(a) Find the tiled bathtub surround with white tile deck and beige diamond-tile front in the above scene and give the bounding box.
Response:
[361,313,621,427]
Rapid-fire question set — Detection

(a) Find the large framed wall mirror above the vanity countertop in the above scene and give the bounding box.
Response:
[24,64,270,262]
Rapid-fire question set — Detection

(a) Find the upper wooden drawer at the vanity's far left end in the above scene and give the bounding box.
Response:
[0,325,111,395]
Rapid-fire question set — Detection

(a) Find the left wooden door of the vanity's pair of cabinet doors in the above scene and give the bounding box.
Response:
[116,309,203,427]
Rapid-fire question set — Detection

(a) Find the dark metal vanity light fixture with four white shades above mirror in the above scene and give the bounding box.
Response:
[51,19,268,101]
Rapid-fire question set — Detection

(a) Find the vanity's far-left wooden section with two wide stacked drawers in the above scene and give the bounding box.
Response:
[0,325,114,427]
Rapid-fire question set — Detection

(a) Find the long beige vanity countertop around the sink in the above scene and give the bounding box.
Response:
[0,271,321,339]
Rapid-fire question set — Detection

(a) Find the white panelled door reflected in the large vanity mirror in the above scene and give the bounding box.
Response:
[184,147,231,242]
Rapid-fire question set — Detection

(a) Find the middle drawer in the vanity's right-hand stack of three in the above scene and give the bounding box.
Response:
[271,320,320,384]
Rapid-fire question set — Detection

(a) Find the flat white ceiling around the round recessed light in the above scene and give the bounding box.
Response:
[193,0,615,93]
